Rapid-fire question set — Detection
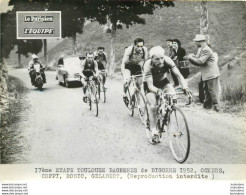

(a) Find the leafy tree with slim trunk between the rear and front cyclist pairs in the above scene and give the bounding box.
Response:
[90,0,174,74]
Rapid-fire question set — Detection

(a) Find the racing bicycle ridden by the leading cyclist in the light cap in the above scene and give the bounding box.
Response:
[150,89,192,163]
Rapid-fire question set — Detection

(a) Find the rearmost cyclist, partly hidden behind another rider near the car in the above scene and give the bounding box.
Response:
[94,46,107,85]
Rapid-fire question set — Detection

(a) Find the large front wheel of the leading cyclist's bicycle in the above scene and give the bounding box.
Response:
[167,106,190,163]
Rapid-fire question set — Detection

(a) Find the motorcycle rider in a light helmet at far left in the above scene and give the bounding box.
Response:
[28,54,46,85]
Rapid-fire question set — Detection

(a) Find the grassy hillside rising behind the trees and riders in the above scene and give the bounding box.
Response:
[4,2,246,87]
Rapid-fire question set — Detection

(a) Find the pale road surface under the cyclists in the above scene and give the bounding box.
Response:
[5,69,246,164]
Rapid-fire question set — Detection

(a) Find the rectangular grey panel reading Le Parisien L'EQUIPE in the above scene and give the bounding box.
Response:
[16,11,61,39]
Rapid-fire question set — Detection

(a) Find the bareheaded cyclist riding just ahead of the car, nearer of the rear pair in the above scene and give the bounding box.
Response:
[81,52,99,103]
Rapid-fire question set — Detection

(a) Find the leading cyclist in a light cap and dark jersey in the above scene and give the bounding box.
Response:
[144,46,188,144]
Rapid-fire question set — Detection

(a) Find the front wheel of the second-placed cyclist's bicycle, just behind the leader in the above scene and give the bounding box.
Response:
[135,92,148,125]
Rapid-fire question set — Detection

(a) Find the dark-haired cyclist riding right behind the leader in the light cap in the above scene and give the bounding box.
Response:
[121,38,148,104]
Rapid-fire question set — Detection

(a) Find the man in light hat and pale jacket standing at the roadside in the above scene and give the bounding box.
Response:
[186,34,220,112]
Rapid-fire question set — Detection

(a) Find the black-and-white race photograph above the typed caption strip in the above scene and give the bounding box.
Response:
[0,0,246,193]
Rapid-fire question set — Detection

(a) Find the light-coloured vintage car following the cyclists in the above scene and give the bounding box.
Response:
[56,56,83,87]
